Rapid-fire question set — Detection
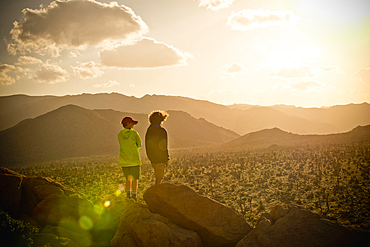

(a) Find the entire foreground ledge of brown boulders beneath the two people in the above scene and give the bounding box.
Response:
[0,168,370,247]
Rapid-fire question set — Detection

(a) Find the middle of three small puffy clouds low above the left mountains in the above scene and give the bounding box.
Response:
[34,64,68,84]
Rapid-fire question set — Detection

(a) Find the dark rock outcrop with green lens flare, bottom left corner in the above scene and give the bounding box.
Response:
[0,167,114,247]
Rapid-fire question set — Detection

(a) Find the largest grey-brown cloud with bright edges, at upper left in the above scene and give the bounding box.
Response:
[8,0,148,56]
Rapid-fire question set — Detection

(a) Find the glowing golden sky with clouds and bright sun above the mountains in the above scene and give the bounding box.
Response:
[0,0,370,107]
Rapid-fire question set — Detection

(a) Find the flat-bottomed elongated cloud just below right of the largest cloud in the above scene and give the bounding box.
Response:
[100,38,189,68]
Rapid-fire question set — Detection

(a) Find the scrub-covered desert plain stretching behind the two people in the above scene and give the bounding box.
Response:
[12,142,370,231]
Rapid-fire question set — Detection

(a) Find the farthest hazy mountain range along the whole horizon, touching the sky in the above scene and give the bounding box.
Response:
[0,93,370,135]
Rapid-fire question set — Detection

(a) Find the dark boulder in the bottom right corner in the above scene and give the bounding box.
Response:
[236,204,370,247]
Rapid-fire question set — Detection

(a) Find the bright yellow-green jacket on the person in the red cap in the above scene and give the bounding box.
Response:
[118,129,142,167]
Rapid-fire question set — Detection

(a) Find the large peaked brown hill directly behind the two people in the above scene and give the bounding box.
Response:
[0,105,239,166]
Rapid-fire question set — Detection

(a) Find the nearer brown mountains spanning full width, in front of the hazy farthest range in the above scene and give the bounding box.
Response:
[0,101,370,167]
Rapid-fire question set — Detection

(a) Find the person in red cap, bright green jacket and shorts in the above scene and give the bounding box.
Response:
[118,117,142,201]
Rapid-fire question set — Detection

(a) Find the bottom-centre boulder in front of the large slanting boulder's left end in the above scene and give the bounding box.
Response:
[111,202,202,247]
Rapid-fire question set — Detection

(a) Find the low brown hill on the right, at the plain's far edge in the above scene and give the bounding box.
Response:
[221,125,370,149]
